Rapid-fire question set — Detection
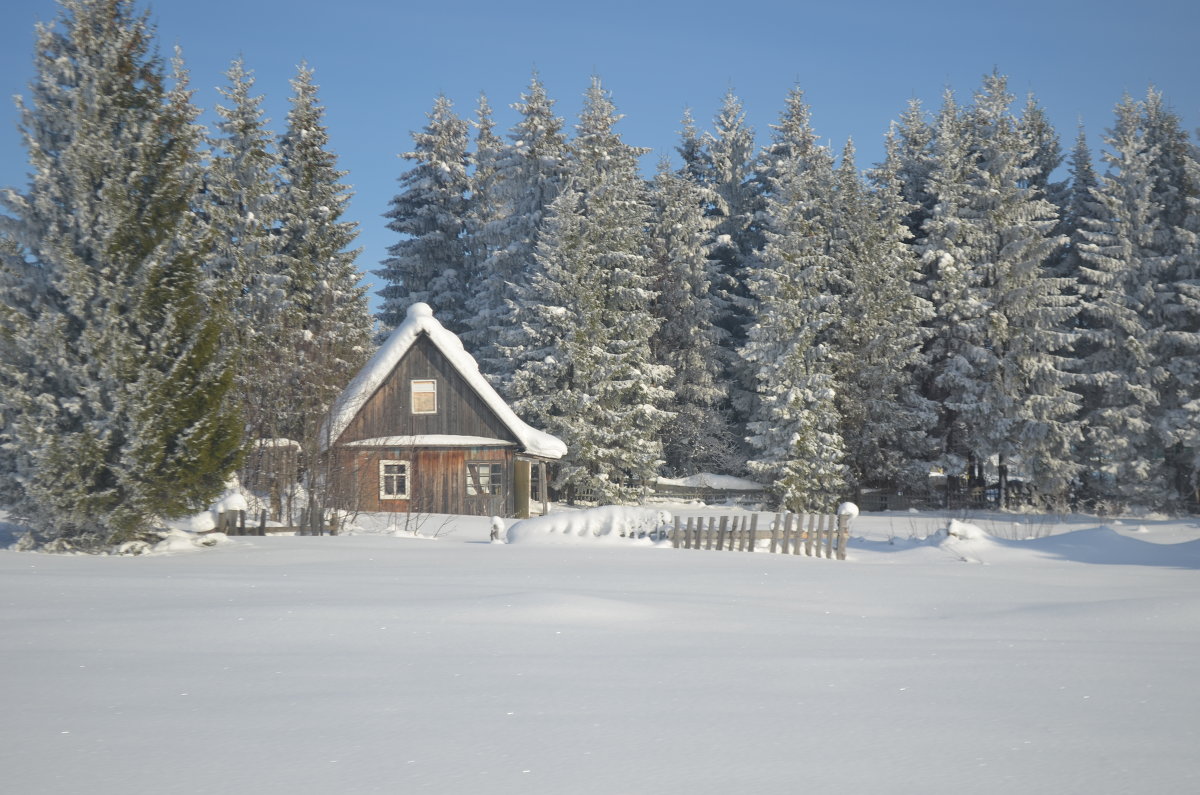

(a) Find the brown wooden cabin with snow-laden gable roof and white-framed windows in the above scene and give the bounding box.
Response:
[322,304,566,516]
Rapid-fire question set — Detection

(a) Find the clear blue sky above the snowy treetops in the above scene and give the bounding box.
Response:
[0,0,1200,312]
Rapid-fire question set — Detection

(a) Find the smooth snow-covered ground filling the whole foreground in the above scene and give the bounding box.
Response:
[0,506,1200,795]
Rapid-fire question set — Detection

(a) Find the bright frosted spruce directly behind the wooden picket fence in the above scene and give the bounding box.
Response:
[740,125,846,510]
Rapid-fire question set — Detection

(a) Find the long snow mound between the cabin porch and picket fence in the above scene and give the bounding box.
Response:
[505,506,671,544]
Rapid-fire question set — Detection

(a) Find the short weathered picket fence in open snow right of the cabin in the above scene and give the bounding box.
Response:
[671,513,850,561]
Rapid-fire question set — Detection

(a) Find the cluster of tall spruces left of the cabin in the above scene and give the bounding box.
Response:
[0,0,373,550]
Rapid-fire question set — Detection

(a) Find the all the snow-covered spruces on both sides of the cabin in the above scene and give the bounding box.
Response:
[0,0,1200,549]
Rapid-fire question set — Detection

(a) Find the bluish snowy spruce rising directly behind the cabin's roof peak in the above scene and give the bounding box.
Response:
[373,96,474,334]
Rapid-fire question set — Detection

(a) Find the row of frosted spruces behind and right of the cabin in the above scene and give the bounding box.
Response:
[374,73,1200,510]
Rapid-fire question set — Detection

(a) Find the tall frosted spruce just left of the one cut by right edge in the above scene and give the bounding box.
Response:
[1078,96,1175,509]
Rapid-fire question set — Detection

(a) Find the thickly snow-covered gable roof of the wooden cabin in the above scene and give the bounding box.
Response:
[320,304,566,459]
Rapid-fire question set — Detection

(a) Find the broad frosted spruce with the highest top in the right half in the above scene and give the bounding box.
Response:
[918,73,1079,511]
